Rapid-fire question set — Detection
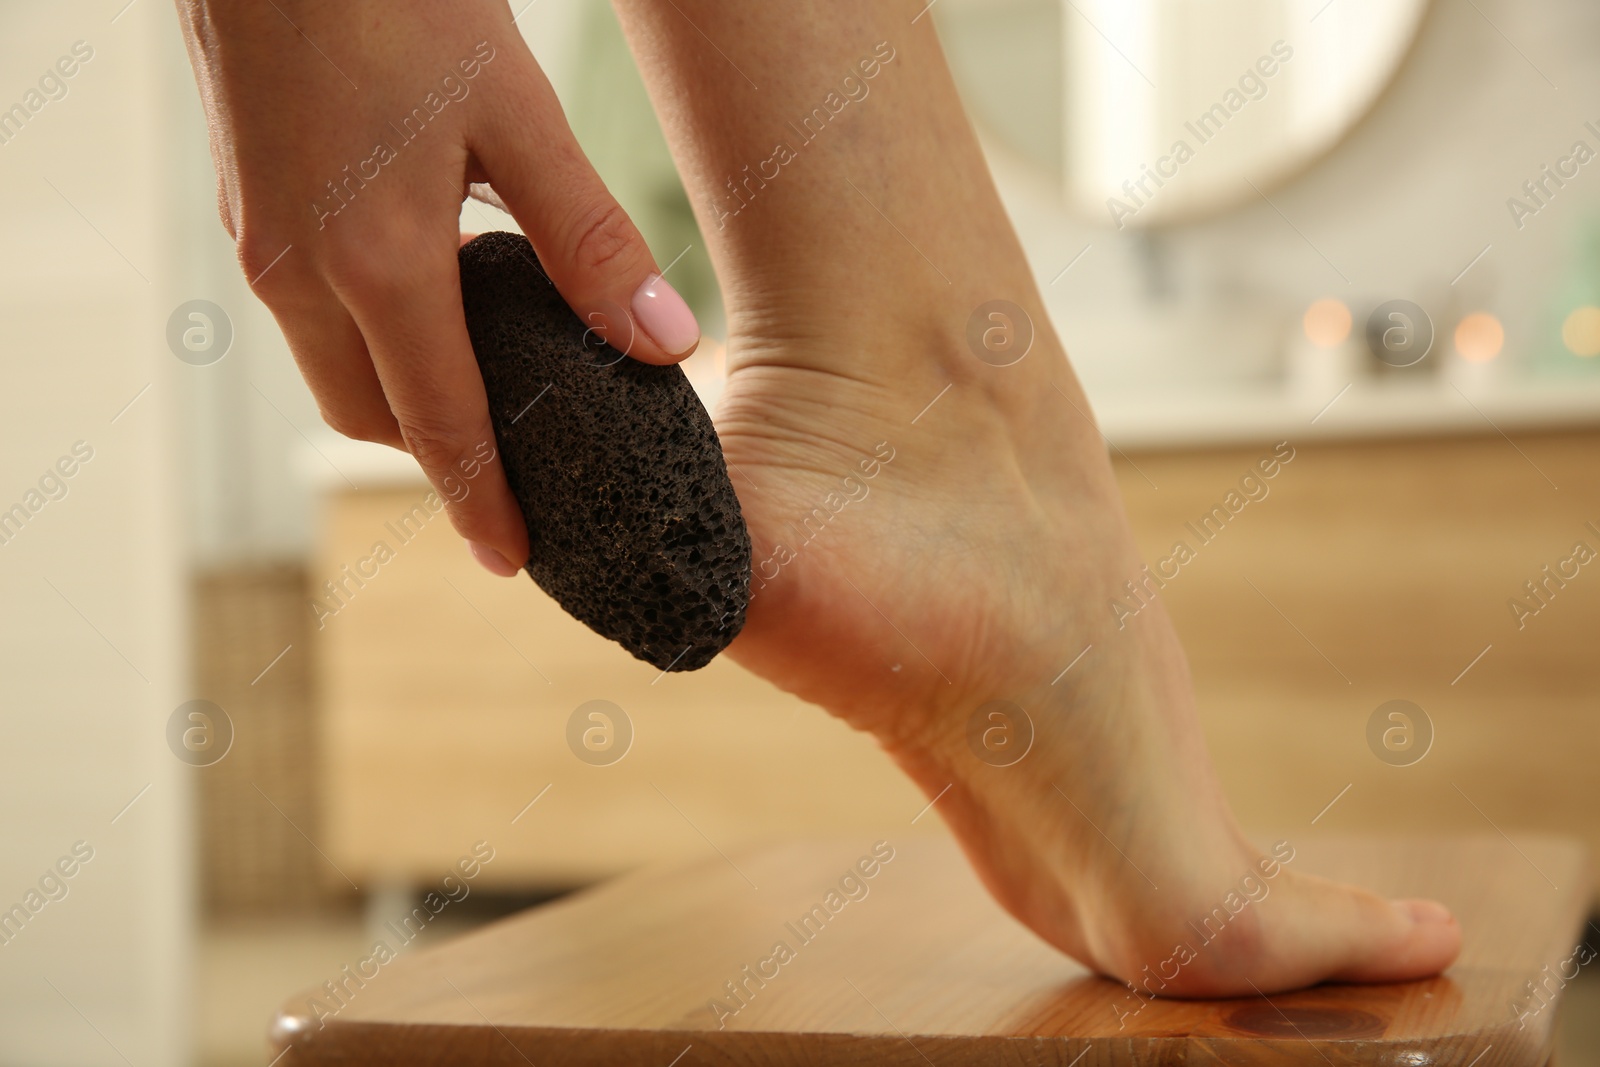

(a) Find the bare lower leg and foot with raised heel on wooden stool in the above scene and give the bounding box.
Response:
[616,0,1461,997]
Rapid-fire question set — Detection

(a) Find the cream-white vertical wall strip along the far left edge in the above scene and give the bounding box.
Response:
[0,0,192,1065]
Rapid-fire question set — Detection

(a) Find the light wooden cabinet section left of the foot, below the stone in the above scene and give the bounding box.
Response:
[312,486,939,888]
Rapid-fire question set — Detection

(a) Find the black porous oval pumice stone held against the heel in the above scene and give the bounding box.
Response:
[461,234,750,670]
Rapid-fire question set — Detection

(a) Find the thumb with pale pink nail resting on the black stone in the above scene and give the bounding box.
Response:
[472,62,701,363]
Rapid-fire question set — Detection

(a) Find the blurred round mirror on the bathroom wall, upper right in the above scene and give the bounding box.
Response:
[933,0,1427,229]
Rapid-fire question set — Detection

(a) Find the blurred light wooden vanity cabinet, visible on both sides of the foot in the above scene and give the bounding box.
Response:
[312,434,1600,886]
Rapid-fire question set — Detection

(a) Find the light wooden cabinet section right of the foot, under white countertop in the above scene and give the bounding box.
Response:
[1118,434,1600,870]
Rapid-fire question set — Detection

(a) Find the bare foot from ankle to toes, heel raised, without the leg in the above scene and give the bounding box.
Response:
[718,294,1461,997]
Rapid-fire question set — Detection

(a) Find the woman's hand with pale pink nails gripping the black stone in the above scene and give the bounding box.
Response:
[178,0,699,576]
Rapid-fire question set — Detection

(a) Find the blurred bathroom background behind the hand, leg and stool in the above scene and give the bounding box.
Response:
[0,0,1600,1067]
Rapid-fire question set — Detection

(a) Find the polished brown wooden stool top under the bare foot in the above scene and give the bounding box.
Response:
[272,837,1589,1067]
